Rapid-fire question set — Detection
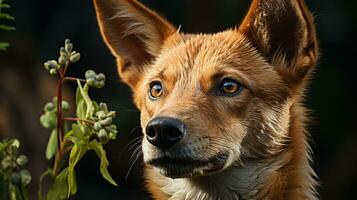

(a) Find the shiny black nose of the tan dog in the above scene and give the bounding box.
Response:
[146,117,185,149]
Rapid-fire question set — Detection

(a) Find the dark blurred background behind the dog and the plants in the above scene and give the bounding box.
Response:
[0,0,357,200]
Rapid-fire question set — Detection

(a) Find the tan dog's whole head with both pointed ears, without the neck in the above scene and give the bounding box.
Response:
[94,0,318,177]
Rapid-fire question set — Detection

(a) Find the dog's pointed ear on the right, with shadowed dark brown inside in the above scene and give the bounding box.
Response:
[239,0,318,81]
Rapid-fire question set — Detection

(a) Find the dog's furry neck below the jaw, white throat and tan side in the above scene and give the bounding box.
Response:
[147,102,317,200]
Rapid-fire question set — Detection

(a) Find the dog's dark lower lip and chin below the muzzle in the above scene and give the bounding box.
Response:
[147,153,229,178]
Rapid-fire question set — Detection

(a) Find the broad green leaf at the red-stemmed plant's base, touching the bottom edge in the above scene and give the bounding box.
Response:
[46,168,69,200]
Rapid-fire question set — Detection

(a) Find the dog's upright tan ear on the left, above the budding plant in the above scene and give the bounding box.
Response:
[94,0,176,88]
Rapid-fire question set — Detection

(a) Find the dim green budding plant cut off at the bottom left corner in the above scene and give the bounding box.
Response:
[0,139,31,200]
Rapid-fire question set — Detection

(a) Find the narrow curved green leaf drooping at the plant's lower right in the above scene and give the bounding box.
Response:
[88,140,118,186]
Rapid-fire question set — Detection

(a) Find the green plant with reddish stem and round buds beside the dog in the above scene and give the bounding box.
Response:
[39,39,117,200]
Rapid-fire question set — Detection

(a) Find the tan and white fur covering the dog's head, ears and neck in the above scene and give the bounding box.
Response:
[94,0,318,200]
